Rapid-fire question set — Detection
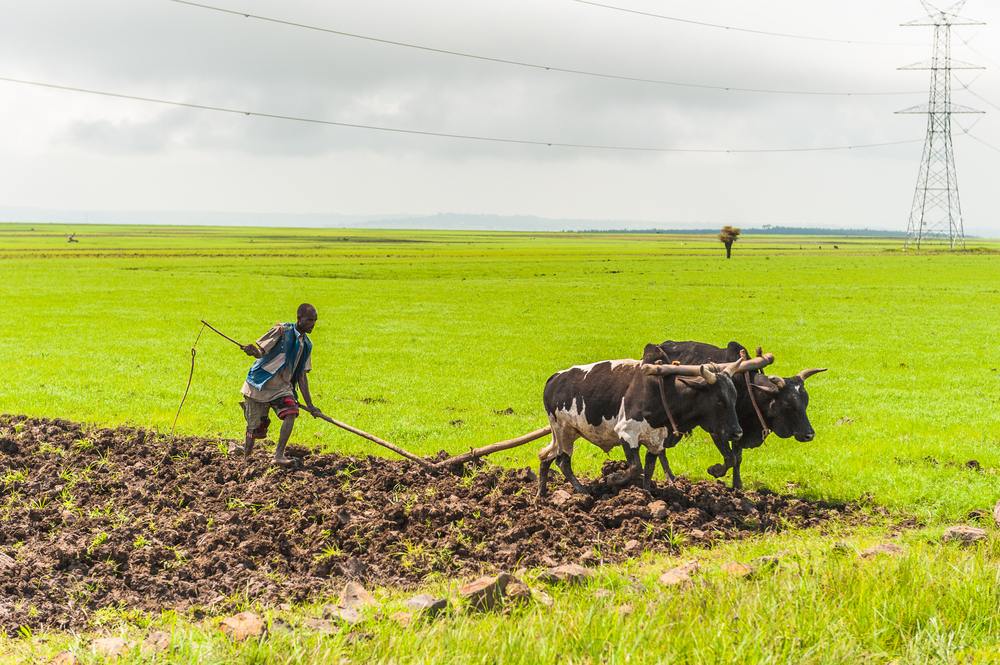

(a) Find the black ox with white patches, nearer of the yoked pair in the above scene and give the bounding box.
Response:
[538,344,774,496]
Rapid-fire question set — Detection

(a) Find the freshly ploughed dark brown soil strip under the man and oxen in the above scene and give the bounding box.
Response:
[0,416,857,634]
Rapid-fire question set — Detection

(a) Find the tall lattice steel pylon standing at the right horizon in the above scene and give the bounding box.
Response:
[896,0,985,249]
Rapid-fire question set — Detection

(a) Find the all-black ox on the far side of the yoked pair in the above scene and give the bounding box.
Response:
[646,341,826,489]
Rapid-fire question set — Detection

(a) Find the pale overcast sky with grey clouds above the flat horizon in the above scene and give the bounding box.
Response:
[0,0,1000,237]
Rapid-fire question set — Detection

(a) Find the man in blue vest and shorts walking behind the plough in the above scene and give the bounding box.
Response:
[240,303,320,468]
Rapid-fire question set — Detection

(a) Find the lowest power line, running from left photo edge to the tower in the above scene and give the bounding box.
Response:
[0,77,923,153]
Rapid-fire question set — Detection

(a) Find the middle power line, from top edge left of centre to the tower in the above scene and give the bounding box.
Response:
[162,0,923,97]
